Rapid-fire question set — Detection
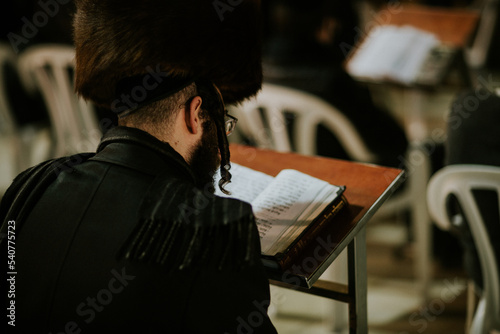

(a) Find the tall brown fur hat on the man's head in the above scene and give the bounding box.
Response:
[74,0,262,108]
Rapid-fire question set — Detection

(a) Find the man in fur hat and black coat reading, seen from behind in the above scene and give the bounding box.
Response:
[0,0,276,333]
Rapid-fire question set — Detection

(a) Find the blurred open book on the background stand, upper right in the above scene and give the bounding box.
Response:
[346,25,456,85]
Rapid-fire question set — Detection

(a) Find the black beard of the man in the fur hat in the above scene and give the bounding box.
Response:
[189,121,220,194]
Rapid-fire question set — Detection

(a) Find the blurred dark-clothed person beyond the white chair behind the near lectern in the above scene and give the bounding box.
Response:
[263,0,408,168]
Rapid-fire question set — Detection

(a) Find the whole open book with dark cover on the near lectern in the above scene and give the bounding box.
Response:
[216,163,347,269]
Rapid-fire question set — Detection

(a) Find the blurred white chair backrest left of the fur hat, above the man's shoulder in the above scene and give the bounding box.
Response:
[19,45,101,156]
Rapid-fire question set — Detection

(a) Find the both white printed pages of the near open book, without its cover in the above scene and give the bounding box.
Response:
[214,163,341,255]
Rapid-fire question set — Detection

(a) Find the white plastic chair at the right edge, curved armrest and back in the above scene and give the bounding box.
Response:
[427,165,500,334]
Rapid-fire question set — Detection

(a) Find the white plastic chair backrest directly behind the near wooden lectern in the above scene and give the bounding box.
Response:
[231,83,376,162]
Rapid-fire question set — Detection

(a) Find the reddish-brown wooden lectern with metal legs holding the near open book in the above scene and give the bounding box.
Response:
[231,144,403,333]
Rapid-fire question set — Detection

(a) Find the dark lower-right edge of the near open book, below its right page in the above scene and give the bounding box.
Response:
[278,195,347,270]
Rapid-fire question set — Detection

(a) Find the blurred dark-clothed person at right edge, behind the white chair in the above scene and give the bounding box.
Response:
[445,87,500,289]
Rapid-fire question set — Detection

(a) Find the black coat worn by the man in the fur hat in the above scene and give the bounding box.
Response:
[0,127,275,333]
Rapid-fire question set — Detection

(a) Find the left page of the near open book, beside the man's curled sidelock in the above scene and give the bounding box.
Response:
[214,162,274,203]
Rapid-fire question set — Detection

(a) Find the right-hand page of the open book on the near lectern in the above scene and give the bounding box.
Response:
[252,170,336,255]
